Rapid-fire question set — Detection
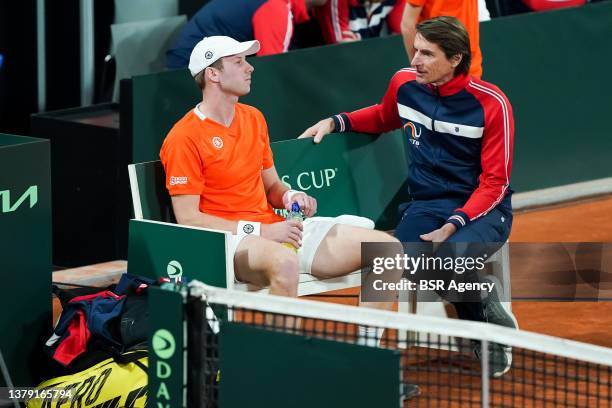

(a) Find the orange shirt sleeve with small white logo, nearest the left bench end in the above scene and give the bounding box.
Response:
[159,131,204,196]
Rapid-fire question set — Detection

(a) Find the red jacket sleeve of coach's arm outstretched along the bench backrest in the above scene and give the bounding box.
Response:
[333,71,409,133]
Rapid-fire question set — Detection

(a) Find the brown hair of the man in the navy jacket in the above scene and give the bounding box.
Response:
[416,16,472,76]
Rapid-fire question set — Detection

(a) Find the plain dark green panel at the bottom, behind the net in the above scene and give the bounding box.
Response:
[219,322,401,408]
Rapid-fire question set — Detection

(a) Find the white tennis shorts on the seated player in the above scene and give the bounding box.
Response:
[228,215,374,274]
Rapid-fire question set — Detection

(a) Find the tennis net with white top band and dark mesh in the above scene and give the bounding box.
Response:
[187,282,612,408]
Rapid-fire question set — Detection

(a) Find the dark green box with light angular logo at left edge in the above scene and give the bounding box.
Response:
[0,134,52,387]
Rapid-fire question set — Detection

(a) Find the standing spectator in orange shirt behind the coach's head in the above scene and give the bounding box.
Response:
[400,0,482,78]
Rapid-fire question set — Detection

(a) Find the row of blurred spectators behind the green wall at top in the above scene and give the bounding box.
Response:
[167,0,587,71]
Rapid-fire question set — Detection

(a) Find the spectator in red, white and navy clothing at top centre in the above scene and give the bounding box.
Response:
[313,0,404,44]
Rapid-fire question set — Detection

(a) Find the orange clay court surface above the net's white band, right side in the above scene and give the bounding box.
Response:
[310,196,612,347]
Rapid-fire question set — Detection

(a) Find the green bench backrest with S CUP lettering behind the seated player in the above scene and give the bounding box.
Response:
[129,132,408,229]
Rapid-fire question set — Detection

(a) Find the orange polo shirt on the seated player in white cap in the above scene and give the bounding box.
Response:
[159,103,283,223]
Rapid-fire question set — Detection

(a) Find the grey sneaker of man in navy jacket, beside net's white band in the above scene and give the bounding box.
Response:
[472,275,518,377]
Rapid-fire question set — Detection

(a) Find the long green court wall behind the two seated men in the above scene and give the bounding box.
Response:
[128,2,612,192]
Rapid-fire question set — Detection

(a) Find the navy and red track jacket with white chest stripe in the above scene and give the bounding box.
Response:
[333,68,514,228]
